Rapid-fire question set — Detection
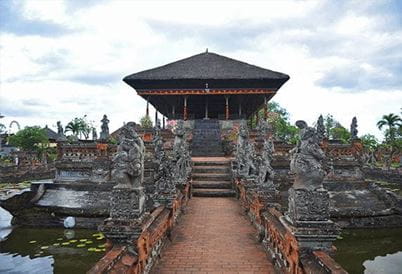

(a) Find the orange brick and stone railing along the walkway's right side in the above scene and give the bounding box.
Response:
[234,179,347,273]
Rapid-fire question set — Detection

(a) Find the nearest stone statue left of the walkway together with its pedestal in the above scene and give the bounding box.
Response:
[99,122,145,247]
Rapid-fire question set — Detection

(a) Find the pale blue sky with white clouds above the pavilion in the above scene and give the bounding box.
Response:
[0,0,402,137]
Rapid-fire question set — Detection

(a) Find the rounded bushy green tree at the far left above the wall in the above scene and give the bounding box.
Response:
[8,126,49,153]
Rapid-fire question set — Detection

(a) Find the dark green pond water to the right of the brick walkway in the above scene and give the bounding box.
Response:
[334,228,402,274]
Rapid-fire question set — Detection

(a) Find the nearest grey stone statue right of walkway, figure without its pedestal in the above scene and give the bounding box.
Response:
[290,120,325,191]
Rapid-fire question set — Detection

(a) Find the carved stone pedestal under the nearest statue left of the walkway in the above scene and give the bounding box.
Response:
[99,187,145,246]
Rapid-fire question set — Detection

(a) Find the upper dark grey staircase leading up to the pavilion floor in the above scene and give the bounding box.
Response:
[191,119,224,157]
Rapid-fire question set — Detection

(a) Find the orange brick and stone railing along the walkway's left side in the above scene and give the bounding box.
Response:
[88,182,191,274]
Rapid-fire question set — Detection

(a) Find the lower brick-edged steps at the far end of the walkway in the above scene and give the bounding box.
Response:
[192,157,236,197]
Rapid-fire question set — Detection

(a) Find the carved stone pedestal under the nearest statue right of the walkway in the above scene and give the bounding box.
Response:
[283,188,339,250]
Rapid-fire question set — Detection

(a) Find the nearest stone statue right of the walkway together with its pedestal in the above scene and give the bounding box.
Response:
[285,121,339,253]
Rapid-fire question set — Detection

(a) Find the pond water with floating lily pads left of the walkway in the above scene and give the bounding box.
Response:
[0,228,105,274]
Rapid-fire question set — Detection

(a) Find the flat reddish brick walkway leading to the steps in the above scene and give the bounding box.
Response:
[152,198,274,274]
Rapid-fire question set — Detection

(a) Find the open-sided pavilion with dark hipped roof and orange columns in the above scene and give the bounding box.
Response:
[123,50,289,120]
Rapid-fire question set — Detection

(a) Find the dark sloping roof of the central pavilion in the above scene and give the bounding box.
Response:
[123,52,289,89]
